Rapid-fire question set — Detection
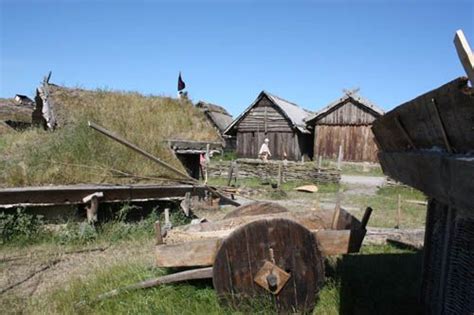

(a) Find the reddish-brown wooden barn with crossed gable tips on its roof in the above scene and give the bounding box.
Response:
[306,92,383,162]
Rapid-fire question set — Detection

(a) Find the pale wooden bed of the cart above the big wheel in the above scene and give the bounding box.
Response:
[156,203,370,267]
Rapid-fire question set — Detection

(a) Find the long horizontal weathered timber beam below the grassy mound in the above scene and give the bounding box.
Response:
[0,185,206,205]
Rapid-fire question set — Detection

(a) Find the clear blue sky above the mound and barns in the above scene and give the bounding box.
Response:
[0,0,474,115]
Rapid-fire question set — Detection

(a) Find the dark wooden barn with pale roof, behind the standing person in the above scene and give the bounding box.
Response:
[224,91,313,160]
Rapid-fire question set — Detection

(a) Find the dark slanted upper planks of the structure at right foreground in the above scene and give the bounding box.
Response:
[372,77,474,154]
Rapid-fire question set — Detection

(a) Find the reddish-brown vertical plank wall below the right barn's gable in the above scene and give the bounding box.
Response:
[314,125,378,162]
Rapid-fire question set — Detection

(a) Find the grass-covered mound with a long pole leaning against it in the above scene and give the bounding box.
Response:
[0,85,219,187]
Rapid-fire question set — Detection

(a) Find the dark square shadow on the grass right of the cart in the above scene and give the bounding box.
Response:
[333,252,423,314]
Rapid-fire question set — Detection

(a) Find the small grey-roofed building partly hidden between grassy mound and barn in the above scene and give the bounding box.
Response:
[196,101,235,150]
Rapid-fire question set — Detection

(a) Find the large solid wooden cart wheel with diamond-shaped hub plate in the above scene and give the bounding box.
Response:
[213,219,324,312]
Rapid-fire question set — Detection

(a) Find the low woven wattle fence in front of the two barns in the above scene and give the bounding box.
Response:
[208,159,341,183]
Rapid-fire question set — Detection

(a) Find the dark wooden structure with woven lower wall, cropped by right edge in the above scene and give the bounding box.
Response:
[373,77,474,314]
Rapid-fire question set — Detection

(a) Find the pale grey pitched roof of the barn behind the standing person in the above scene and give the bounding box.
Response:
[224,91,312,133]
